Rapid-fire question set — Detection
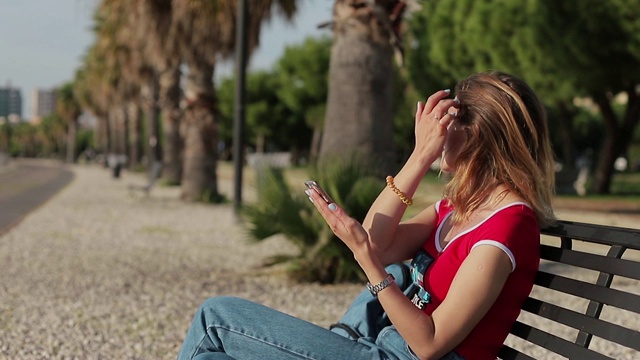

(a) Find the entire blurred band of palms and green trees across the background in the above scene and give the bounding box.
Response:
[5,0,640,197]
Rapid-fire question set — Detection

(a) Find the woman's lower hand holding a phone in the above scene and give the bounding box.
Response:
[305,189,369,259]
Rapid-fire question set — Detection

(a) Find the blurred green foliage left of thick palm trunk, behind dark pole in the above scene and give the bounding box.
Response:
[217,38,331,160]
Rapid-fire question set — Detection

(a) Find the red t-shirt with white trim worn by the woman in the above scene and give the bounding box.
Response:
[424,201,540,360]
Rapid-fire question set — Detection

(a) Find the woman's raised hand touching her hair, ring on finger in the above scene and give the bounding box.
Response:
[414,90,460,163]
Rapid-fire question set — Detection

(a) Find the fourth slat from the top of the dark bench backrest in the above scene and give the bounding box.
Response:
[523,298,640,350]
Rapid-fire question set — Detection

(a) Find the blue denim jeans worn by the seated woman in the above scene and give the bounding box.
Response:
[178,262,464,360]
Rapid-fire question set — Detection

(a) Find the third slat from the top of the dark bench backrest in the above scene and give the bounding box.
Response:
[535,271,640,314]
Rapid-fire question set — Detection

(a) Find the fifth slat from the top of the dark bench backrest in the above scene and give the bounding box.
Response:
[508,321,613,360]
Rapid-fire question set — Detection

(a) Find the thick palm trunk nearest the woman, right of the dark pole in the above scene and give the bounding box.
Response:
[319,1,394,173]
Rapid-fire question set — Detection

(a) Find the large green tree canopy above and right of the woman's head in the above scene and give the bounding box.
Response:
[410,0,640,193]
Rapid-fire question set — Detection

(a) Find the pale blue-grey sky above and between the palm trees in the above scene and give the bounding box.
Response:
[0,0,334,119]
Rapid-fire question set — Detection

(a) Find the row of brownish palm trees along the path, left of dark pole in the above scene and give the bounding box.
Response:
[70,0,296,201]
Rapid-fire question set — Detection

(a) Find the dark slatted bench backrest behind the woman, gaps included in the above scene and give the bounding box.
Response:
[500,221,640,360]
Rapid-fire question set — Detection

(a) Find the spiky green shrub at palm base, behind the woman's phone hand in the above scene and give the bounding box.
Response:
[242,160,384,283]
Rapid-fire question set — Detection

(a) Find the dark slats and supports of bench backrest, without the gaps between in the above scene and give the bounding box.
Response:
[500,221,640,360]
